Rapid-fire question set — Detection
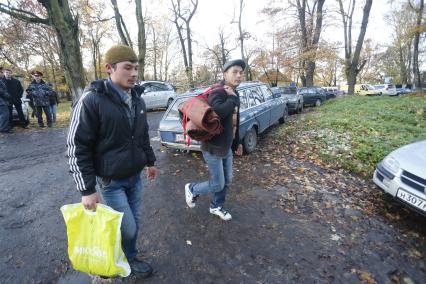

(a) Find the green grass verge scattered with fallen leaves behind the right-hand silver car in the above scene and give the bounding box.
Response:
[271,96,426,176]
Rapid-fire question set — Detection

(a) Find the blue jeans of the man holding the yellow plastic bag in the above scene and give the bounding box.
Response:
[96,173,142,261]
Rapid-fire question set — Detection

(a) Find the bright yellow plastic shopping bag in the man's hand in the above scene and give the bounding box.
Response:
[61,203,131,277]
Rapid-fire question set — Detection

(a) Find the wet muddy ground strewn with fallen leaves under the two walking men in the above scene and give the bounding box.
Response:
[0,112,426,283]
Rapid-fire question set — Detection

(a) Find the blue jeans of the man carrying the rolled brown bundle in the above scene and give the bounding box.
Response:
[190,149,233,208]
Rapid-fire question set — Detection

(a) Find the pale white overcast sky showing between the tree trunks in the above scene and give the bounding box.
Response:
[118,0,392,60]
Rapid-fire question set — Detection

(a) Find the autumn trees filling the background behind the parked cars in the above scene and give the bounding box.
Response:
[0,0,426,99]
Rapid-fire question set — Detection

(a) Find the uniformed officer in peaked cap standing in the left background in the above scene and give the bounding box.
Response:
[27,71,54,127]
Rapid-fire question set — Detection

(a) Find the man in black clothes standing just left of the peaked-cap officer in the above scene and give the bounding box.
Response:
[3,68,29,128]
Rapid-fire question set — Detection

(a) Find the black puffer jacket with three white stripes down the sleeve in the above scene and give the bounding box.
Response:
[67,80,155,195]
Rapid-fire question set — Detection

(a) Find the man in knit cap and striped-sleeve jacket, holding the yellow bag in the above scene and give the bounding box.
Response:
[67,45,157,277]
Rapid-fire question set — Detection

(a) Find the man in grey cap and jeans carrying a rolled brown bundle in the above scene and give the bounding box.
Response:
[185,60,245,221]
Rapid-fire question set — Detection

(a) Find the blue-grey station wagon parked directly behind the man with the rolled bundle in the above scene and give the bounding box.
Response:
[158,82,288,153]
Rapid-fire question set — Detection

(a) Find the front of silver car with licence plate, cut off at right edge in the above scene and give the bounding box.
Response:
[373,140,426,216]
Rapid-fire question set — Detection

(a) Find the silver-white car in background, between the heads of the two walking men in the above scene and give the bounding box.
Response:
[138,81,177,109]
